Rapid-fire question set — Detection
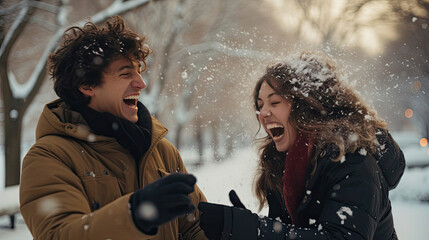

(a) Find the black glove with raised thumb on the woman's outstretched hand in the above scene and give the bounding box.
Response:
[198,190,258,240]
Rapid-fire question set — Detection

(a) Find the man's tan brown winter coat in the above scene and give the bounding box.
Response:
[20,100,206,240]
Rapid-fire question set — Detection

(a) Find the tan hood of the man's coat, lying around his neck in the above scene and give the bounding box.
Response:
[36,99,167,144]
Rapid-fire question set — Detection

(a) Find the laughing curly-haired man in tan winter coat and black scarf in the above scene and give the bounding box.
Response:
[20,17,206,240]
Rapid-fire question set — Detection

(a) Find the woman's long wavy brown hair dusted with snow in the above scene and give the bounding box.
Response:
[253,52,386,210]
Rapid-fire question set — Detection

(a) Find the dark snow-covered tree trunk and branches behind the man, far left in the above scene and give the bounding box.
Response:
[0,0,154,186]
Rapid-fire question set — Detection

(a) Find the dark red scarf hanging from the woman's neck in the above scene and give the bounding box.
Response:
[283,134,313,224]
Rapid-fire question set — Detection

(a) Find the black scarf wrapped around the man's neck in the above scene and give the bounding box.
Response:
[78,102,152,162]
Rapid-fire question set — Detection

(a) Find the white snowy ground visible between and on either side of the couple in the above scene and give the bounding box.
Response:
[0,149,429,240]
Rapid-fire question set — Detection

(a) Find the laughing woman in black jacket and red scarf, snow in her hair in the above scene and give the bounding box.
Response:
[199,52,405,240]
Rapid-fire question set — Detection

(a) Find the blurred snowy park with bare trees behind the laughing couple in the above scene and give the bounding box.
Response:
[0,0,429,238]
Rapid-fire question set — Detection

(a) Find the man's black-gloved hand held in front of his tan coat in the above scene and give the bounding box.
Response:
[129,173,197,235]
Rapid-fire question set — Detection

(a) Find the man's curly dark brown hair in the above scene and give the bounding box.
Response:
[48,16,151,107]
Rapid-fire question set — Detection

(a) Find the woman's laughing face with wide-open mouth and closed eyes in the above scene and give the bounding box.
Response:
[257,82,297,152]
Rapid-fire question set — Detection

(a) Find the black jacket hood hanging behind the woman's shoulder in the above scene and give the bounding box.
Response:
[374,130,405,190]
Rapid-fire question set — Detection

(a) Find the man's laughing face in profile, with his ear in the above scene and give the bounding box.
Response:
[79,57,146,123]
